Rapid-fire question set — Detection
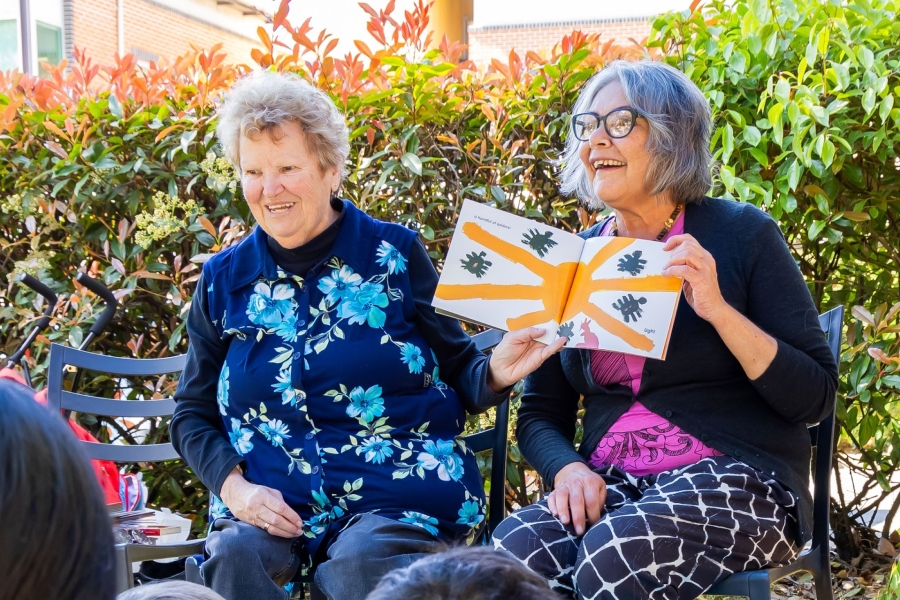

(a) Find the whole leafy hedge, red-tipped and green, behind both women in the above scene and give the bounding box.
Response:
[0,0,900,557]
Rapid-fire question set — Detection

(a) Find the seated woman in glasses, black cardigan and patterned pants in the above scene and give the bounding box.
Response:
[494,61,837,600]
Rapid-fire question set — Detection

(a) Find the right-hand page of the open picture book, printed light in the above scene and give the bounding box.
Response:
[557,237,683,359]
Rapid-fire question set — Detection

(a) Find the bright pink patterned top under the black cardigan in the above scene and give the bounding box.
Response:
[589,211,722,477]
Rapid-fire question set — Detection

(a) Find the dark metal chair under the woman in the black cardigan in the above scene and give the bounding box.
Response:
[706,306,844,600]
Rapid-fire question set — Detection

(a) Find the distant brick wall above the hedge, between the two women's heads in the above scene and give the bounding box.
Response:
[469,17,650,64]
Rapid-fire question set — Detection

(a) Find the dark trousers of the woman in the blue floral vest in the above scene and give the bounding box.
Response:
[201,514,439,600]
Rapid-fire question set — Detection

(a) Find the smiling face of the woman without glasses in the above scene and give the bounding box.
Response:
[240,121,340,248]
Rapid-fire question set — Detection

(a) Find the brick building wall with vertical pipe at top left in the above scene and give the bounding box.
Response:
[70,0,262,64]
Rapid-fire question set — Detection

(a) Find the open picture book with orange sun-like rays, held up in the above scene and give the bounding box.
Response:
[432,200,682,359]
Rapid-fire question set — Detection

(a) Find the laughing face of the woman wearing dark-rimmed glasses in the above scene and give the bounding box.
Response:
[579,81,652,209]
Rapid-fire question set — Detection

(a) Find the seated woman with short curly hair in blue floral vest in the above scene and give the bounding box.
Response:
[170,72,563,600]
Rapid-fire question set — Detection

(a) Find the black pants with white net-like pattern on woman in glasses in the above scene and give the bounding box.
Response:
[493,456,799,600]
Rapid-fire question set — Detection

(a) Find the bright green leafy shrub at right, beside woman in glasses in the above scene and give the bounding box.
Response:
[649,0,900,560]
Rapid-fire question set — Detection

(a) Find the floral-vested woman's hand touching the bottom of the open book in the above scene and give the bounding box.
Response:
[488,327,568,392]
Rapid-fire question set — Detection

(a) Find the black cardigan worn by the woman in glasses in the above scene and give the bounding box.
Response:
[516,198,838,542]
